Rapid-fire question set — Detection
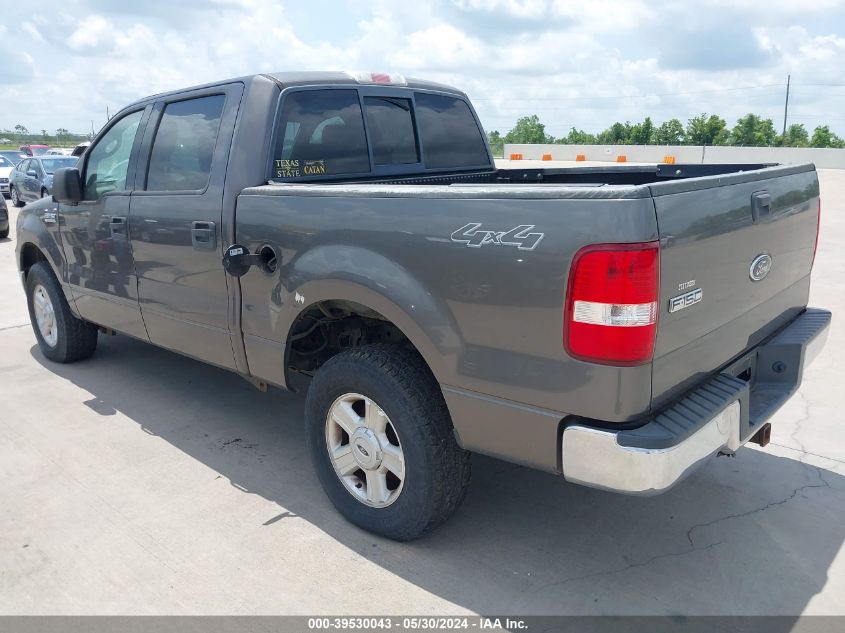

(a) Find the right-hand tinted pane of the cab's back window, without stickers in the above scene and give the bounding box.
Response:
[414,92,490,169]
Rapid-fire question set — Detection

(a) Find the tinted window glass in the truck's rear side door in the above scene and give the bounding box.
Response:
[147,95,226,191]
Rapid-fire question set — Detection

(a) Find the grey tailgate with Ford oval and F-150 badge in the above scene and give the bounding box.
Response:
[651,165,819,409]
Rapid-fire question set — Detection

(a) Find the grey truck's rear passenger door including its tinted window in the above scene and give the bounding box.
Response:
[130,83,243,368]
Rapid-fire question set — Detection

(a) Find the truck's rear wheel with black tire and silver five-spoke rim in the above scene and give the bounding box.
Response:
[305,345,470,541]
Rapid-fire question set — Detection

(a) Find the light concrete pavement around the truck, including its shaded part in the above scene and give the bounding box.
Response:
[0,171,845,614]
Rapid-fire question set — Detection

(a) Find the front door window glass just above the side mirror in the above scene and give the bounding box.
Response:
[83,110,143,200]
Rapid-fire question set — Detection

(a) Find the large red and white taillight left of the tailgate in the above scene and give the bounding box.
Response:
[563,242,660,365]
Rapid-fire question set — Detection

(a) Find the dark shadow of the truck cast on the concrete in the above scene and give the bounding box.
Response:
[31,337,845,615]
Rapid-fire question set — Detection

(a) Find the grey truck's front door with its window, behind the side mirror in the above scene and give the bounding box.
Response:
[59,108,149,339]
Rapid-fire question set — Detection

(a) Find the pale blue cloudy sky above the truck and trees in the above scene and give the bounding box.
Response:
[0,0,845,136]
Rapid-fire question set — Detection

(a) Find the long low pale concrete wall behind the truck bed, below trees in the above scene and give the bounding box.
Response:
[504,143,845,169]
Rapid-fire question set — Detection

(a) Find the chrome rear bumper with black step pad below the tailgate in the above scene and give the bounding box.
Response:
[561,308,831,495]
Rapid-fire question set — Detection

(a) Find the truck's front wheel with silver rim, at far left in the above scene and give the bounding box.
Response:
[26,262,98,363]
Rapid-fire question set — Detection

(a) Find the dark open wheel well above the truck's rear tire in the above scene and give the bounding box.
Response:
[286,300,416,376]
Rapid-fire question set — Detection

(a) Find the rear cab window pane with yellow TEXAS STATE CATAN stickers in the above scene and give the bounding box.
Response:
[273,90,370,178]
